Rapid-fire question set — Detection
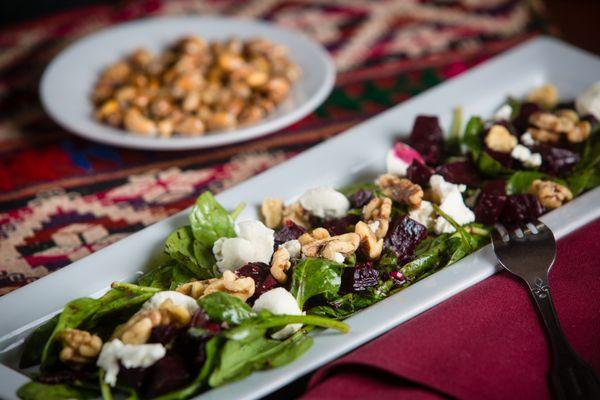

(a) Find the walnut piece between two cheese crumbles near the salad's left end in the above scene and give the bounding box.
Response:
[111,299,192,344]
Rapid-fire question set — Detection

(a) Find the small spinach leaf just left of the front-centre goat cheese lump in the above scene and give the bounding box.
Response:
[198,292,254,326]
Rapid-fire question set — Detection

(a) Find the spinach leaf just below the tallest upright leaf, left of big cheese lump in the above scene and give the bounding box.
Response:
[165,225,216,279]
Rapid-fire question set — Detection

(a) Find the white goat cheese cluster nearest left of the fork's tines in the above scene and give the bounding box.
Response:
[429,174,475,234]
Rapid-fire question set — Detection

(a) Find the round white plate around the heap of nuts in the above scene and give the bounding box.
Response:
[40,16,335,150]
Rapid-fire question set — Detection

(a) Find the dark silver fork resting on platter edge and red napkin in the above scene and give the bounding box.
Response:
[492,221,600,400]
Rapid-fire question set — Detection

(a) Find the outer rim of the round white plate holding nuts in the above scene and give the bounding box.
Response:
[38,14,337,151]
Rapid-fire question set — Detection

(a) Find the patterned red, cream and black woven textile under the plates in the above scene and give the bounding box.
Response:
[0,0,548,294]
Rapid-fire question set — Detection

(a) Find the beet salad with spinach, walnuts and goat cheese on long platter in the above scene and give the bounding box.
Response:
[18,84,600,399]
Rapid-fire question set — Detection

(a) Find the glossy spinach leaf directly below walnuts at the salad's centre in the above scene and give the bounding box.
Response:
[290,258,344,308]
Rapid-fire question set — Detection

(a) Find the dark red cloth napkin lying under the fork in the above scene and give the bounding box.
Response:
[304,220,600,399]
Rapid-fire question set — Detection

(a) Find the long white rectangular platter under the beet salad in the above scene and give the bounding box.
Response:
[0,38,600,399]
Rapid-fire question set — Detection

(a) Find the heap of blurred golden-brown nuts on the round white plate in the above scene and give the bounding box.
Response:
[91,36,300,138]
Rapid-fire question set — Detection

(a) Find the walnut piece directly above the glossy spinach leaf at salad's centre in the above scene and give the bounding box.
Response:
[298,228,360,263]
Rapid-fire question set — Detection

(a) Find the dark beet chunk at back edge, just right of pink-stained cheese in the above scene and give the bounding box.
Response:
[410,115,444,165]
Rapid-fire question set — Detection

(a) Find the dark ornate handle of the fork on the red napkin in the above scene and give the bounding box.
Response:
[527,277,600,400]
